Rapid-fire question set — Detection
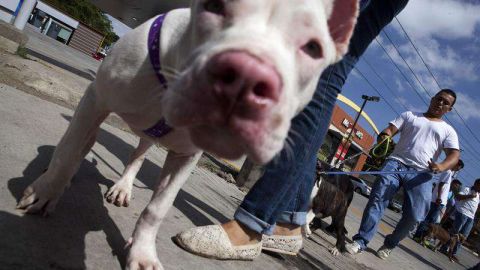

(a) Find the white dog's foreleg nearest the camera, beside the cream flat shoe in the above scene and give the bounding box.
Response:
[127,151,201,270]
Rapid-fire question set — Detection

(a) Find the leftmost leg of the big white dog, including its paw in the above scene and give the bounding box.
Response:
[17,83,109,215]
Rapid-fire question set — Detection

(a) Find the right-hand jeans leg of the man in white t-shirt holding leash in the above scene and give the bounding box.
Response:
[384,173,432,249]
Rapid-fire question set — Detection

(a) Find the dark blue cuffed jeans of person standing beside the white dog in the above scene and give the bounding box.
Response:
[234,0,408,234]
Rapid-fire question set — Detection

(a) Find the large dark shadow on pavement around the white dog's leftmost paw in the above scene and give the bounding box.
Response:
[0,145,126,269]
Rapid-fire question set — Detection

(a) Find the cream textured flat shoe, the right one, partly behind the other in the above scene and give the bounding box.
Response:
[262,234,303,255]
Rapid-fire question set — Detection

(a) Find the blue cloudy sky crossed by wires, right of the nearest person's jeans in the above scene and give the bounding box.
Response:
[339,0,480,186]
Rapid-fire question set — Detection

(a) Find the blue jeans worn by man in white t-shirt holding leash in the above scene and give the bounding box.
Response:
[352,159,432,250]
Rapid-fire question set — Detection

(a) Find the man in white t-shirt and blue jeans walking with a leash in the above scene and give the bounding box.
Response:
[346,89,460,259]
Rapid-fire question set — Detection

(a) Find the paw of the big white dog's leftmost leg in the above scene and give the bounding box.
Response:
[17,173,66,216]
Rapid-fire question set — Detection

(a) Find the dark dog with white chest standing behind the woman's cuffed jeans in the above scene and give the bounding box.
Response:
[305,163,354,256]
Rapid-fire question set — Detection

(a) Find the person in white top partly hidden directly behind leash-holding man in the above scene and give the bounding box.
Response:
[413,159,464,242]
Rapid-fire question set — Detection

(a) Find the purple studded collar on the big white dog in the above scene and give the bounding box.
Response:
[143,14,173,138]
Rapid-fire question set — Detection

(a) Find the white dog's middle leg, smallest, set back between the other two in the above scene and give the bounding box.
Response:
[105,138,153,207]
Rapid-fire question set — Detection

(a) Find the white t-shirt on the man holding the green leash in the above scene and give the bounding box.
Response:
[390,111,459,170]
